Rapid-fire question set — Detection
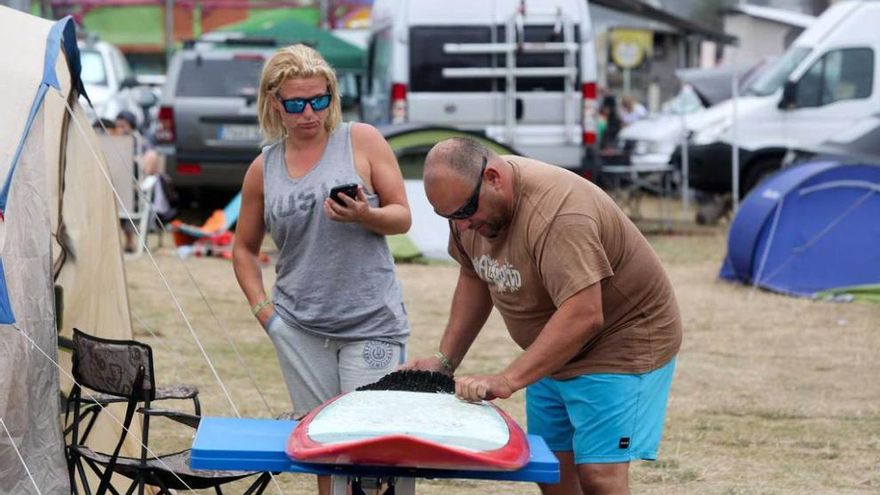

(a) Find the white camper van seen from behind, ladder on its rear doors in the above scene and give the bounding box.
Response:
[361,0,596,169]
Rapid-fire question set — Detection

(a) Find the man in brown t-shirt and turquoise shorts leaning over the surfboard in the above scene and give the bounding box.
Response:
[405,138,681,494]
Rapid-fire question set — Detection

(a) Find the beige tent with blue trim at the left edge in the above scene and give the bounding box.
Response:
[0,7,139,494]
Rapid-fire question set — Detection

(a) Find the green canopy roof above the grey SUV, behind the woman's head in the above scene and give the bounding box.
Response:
[218,9,365,72]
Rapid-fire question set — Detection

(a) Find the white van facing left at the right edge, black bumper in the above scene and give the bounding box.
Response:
[689,1,880,203]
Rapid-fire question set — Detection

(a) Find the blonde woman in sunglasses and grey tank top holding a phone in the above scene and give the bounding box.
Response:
[233,45,411,462]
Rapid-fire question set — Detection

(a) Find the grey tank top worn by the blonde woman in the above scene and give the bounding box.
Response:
[263,123,409,342]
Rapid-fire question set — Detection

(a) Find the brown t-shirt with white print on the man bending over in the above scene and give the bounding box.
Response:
[449,156,681,379]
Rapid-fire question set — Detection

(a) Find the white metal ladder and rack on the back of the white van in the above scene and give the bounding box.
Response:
[442,5,584,146]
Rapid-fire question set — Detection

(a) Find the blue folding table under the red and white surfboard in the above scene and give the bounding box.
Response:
[191,417,559,495]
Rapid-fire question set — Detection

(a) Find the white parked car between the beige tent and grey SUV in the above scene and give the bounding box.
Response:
[77,38,144,126]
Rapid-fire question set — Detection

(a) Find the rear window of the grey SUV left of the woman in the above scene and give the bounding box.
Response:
[177,57,265,98]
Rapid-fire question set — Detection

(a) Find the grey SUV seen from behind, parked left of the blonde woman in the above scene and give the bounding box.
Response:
[156,33,357,199]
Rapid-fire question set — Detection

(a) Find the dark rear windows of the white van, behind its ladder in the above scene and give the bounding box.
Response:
[409,26,580,93]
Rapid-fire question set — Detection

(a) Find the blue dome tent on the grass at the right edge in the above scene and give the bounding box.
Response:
[721,160,880,296]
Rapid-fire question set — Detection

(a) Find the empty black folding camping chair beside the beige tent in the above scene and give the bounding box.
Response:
[67,329,270,495]
